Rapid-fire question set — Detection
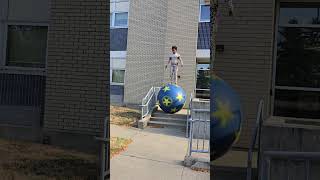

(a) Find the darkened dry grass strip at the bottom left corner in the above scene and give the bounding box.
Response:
[0,139,99,180]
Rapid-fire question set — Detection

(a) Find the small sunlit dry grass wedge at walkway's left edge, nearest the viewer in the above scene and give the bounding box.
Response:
[110,137,132,158]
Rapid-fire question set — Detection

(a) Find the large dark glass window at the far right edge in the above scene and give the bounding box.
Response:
[273,4,320,119]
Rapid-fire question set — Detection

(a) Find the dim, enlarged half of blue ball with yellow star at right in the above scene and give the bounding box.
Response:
[210,76,242,160]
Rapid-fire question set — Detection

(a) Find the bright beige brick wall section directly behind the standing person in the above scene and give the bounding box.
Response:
[164,0,199,103]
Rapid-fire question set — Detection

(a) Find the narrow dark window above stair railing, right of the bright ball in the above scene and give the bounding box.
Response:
[196,63,210,99]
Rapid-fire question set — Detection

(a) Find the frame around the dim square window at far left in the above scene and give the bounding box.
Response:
[0,21,50,73]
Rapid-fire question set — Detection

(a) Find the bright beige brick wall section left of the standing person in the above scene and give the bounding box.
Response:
[124,0,168,104]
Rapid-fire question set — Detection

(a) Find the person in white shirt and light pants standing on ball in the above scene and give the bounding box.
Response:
[165,46,183,85]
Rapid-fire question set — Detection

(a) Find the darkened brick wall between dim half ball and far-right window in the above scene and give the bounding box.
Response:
[214,0,274,147]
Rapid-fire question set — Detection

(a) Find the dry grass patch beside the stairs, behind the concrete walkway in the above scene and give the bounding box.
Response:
[110,106,141,126]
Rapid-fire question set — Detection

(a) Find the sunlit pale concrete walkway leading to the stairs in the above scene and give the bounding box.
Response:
[110,125,210,180]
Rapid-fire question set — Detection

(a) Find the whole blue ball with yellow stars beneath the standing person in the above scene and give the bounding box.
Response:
[158,84,186,114]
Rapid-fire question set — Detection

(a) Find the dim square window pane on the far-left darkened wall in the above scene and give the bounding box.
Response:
[6,25,48,68]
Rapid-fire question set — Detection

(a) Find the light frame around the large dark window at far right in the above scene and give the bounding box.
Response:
[269,1,320,121]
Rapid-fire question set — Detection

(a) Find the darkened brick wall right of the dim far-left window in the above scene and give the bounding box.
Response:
[44,0,110,141]
